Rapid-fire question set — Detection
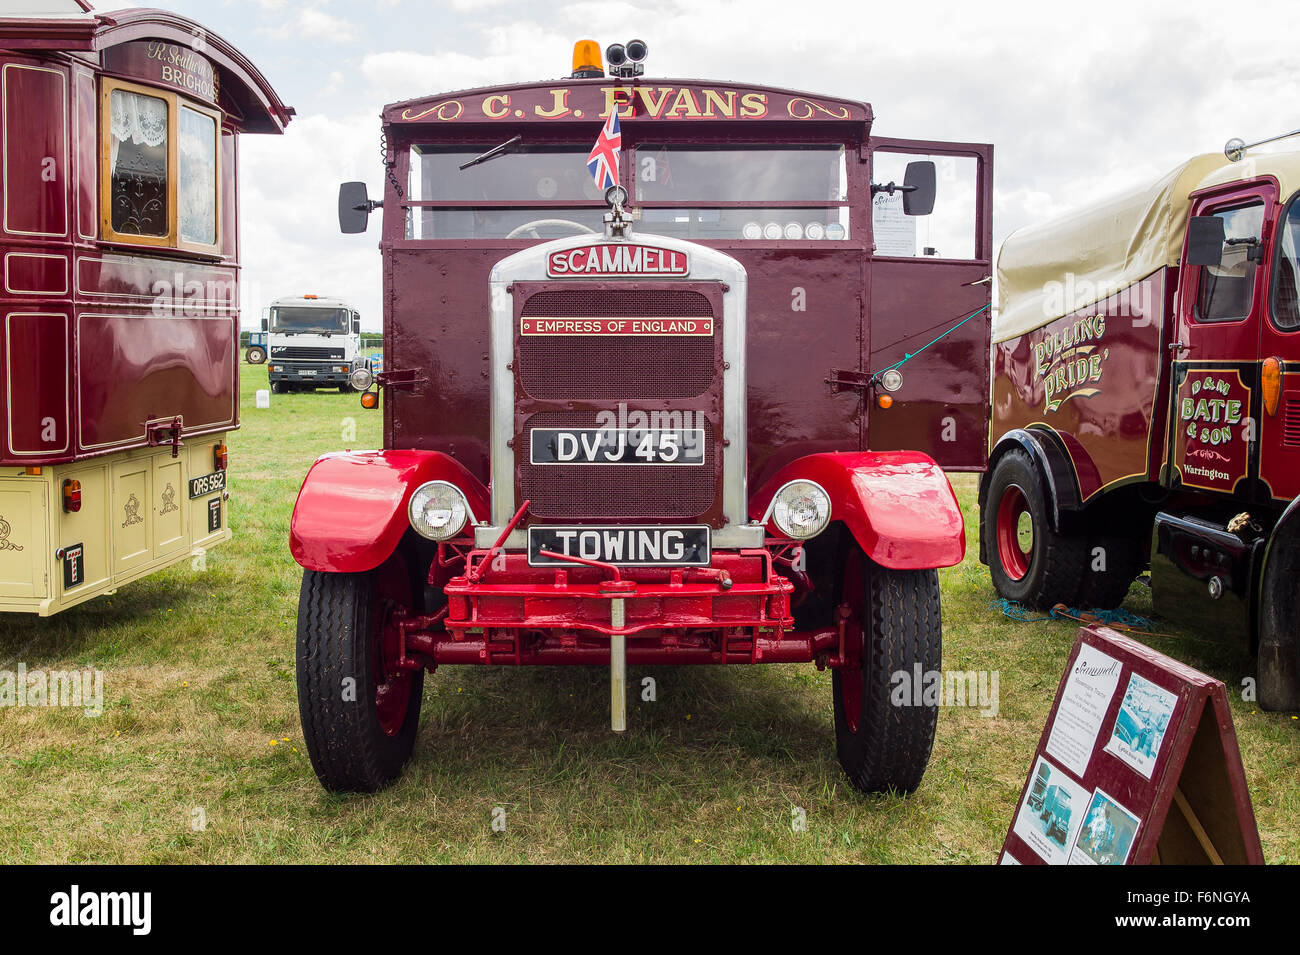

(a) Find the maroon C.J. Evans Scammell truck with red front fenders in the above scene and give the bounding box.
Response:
[291,44,992,791]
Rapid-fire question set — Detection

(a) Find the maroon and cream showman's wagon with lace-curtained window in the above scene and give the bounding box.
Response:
[0,0,291,615]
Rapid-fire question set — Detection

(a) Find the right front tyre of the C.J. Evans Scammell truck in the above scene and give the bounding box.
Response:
[831,544,943,793]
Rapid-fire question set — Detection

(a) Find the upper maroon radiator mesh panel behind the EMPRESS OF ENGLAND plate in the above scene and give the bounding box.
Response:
[519,288,722,401]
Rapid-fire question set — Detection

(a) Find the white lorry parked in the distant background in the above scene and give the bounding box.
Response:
[261,295,371,394]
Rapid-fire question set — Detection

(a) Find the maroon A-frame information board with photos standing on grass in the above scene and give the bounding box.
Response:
[1001,625,1264,865]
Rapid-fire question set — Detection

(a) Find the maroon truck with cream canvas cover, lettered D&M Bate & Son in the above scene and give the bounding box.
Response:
[980,140,1300,709]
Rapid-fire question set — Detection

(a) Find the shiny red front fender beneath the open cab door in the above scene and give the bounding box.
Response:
[749,451,966,570]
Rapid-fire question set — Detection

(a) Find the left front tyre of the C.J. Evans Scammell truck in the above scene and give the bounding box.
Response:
[298,555,424,793]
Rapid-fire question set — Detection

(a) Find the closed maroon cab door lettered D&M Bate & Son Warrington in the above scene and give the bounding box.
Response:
[1165,181,1278,503]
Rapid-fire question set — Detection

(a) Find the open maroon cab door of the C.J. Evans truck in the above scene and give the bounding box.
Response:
[863,136,993,470]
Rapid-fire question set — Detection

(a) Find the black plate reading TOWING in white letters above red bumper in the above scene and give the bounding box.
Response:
[528,524,710,568]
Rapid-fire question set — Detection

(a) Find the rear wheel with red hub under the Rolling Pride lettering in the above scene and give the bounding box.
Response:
[980,448,1088,609]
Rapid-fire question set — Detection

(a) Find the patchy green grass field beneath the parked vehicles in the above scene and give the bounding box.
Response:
[0,365,1300,863]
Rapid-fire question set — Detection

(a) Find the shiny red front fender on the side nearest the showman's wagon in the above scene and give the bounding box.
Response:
[289,451,490,573]
